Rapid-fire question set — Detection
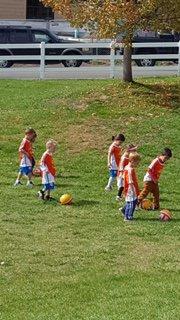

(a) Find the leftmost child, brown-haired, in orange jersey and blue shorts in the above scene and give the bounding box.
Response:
[14,128,37,188]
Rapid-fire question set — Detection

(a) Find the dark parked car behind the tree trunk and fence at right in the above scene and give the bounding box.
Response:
[94,32,180,67]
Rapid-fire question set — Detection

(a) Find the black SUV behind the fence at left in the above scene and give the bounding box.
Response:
[0,26,90,68]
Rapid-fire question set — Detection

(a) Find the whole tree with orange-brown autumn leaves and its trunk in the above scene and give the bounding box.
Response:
[41,0,180,81]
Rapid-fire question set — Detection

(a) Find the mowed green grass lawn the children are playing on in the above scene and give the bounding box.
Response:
[0,78,180,320]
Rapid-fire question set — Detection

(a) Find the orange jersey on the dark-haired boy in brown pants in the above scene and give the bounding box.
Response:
[145,157,164,182]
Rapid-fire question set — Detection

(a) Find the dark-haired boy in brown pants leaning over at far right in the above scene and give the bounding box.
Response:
[138,148,172,210]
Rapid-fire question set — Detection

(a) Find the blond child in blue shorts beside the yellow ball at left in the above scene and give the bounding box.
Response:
[38,139,57,200]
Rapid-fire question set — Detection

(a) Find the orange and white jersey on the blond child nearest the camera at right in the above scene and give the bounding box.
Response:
[124,165,139,197]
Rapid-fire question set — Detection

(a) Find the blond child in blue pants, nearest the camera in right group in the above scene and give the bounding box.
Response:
[120,152,140,221]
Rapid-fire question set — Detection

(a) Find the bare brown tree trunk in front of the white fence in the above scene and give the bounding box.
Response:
[123,44,133,82]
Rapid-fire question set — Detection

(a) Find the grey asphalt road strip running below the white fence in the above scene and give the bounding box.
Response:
[0,65,178,79]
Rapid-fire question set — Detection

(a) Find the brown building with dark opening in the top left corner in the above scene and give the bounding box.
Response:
[0,0,60,20]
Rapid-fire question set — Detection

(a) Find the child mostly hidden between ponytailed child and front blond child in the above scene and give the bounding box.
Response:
[116,144,137,201]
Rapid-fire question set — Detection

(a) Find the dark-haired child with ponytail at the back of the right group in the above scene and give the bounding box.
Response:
[105,134,125,191]
